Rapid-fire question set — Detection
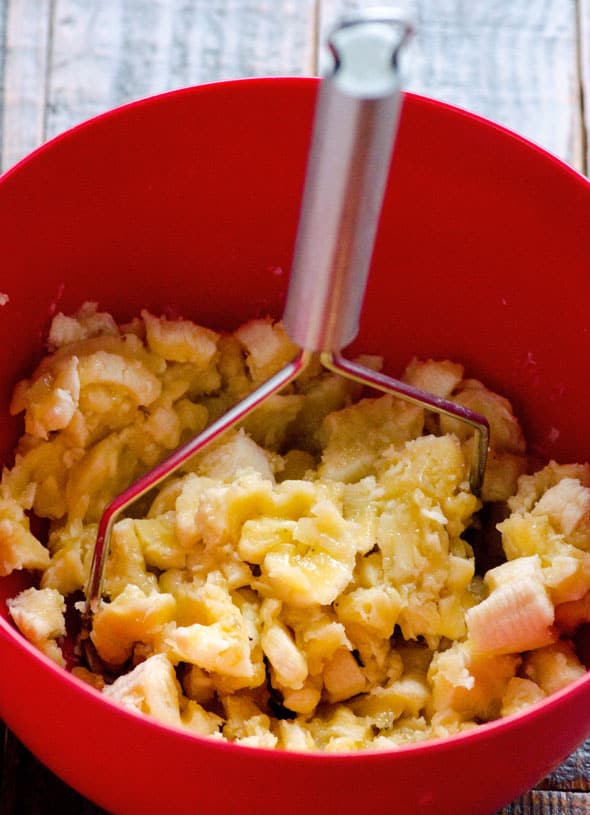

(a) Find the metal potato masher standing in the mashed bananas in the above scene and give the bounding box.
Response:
[83,10,489,633]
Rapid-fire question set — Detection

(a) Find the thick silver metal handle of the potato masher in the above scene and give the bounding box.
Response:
[284,11,412,351]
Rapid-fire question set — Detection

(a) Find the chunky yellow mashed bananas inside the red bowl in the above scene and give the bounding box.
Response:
[0,303,590,751]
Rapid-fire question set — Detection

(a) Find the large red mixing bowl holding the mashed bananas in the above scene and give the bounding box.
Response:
[0,79,590,815]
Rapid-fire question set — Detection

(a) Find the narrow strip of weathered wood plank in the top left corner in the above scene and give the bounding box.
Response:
[0,0,51,169]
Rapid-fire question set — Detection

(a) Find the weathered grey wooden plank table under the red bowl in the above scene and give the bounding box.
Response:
[0,0,590,815]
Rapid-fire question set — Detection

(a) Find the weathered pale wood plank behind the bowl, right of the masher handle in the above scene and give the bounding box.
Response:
[319,0,588,167]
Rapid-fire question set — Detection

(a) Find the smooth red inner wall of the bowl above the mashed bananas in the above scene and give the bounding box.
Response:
[0,79,590,813]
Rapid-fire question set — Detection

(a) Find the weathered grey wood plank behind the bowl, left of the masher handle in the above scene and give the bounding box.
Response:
[45,0,314,143]
